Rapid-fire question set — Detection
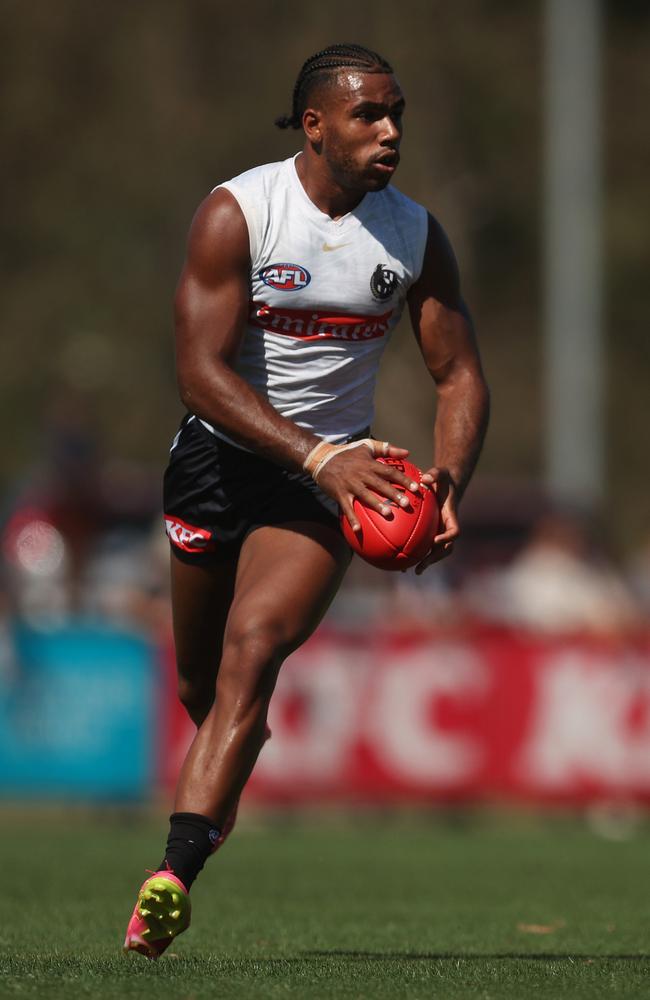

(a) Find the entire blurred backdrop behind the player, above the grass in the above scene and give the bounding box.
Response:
[0,0,650,806]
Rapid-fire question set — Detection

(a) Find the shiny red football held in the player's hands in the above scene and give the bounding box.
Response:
[341,458,439,569]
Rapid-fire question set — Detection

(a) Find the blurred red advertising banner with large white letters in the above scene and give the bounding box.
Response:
[159,630,650,803]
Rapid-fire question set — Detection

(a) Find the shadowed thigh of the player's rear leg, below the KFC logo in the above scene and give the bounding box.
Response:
[170,551,237,684]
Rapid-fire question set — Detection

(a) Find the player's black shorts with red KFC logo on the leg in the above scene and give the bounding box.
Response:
[163,414,339,564]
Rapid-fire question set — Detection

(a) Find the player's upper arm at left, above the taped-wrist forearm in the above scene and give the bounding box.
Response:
[174,189,250,373]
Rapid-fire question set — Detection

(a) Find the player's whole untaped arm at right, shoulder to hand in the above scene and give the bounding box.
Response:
[409,216,489,561]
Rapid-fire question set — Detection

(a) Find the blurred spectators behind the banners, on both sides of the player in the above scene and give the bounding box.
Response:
[0,403,650,638]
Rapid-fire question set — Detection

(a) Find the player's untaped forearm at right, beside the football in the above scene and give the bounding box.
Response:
[434,371,490,499]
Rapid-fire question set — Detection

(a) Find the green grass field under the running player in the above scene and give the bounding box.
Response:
[0,811,650,1000]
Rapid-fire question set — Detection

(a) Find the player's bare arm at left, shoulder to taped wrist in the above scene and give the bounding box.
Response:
[175,188,319,469]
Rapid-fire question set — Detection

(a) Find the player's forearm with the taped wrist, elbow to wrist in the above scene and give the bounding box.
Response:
[178,361,319,470]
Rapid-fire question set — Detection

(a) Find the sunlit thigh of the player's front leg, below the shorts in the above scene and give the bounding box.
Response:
[226,521,351,655]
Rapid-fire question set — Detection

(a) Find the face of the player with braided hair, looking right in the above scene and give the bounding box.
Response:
[310,70,404,191]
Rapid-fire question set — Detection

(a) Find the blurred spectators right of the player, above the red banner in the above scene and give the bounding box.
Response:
[333,490,650,638]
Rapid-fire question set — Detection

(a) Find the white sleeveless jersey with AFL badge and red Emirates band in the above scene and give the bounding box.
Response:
[200,158,427,444]
